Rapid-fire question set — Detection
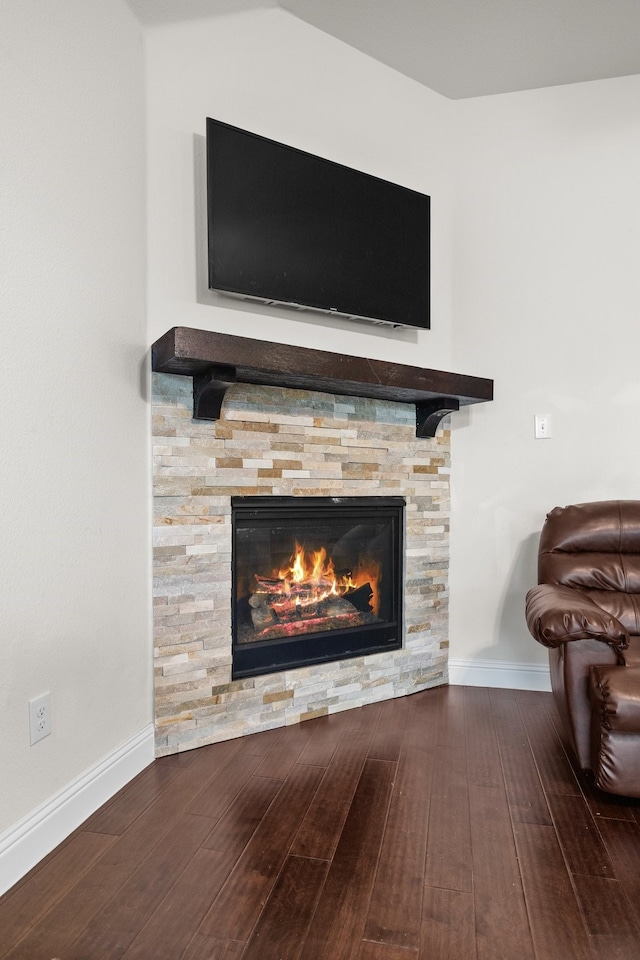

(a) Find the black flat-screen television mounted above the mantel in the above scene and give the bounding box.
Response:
[207,119,430,328]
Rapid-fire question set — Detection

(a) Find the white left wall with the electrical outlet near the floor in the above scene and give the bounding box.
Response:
[0,0,152,860]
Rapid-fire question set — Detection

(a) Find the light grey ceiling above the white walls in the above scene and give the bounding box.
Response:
[129,0,640,100]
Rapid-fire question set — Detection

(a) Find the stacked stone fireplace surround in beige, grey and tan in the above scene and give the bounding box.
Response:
[152,373,450,756]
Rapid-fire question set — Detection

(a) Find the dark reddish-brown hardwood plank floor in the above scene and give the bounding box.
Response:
[0,687,640,960]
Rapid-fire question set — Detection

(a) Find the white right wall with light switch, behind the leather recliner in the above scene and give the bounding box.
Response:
[451,76,640,663]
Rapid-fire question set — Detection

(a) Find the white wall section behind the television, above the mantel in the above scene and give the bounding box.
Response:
[145,9,452,370]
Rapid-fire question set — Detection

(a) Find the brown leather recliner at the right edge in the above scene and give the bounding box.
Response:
[526,500,640,797]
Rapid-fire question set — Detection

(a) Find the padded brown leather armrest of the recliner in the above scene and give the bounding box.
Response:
[526,583,629,654]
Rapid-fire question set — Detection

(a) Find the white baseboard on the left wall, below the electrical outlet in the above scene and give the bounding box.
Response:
[0,724,154,895]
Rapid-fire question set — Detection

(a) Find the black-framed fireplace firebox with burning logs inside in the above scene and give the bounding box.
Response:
[231,496,405,679]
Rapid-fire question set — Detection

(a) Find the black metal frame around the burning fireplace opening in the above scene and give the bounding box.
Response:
[231,496,406,680]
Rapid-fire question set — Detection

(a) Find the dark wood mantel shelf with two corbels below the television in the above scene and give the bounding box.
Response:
[151,327,493,437]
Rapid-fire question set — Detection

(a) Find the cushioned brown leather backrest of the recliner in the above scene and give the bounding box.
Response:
[538,500,640,634]
